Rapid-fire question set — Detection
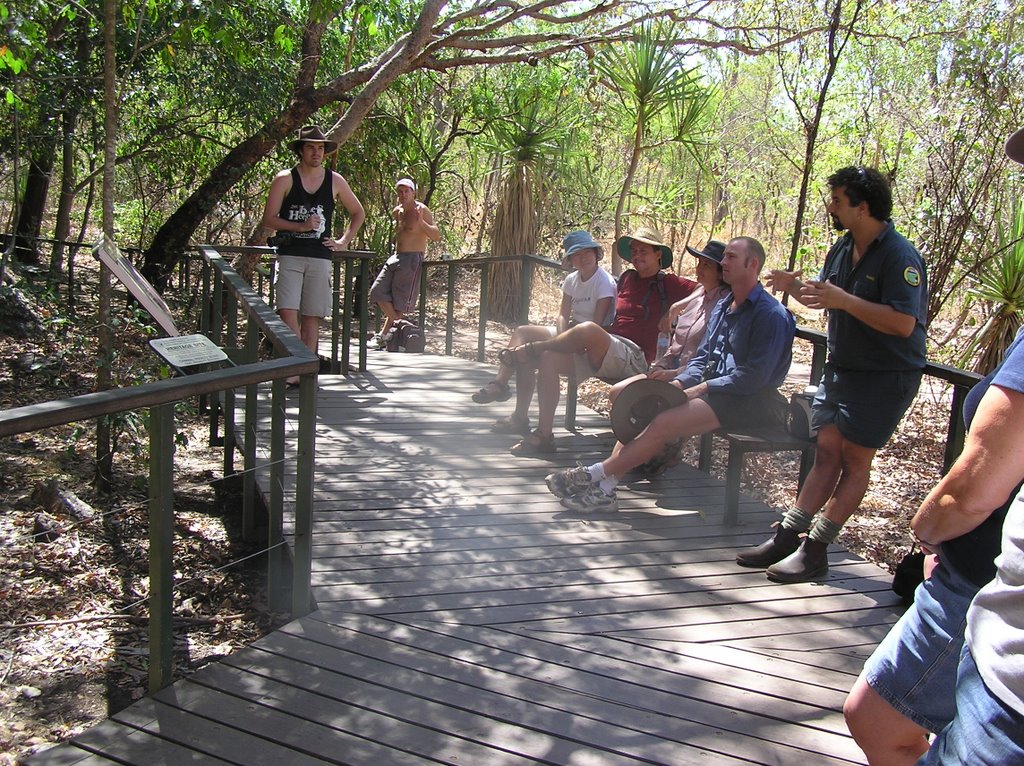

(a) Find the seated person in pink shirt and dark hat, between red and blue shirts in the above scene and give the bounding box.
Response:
[608,240,729,403]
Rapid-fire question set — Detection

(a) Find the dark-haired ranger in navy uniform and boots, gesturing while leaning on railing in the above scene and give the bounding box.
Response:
[736,167,928,583]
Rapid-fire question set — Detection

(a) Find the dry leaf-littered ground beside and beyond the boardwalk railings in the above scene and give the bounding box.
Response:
[0,282,948,766]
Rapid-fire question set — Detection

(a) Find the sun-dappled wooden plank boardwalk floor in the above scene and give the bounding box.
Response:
[30,353,899,766]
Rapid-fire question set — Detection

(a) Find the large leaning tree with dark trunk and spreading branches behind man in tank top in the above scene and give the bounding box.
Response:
[143,0,632,285]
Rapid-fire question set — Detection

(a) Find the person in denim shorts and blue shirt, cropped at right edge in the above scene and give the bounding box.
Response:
[844,125,1024,766]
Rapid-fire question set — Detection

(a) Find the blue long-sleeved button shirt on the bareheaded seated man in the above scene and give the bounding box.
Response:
[676,283,797,394]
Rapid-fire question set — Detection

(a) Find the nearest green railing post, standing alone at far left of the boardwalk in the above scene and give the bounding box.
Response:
[150,402,174,693]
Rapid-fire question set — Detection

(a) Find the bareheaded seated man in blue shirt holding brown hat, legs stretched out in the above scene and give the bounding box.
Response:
[546,237,797,511]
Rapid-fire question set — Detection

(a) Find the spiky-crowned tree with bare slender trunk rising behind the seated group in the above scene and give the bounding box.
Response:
[594,20,712,273]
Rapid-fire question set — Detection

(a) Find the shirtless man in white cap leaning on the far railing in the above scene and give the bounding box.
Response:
[370,178,441,349]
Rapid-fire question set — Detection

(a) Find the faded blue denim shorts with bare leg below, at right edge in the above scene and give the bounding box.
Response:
[862,563,978,732]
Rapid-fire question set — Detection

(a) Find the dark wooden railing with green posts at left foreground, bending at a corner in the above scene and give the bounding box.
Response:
[0,247,319,691]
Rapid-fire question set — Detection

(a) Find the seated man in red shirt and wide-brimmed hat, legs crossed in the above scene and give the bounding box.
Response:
[502,226,697,455]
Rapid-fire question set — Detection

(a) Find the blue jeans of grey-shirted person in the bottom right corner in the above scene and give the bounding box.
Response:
[918,646,1024,766]
